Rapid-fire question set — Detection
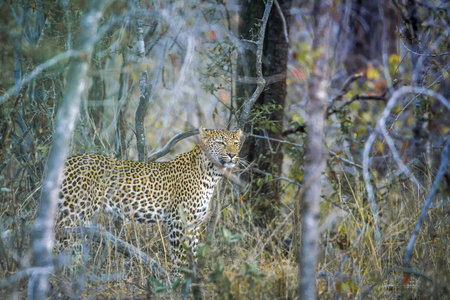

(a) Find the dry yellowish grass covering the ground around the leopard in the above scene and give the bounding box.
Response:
[0,156,450,299]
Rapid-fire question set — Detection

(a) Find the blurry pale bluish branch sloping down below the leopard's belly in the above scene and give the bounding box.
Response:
[58,225,167,277]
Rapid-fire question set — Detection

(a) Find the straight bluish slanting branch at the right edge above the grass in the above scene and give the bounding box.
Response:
[403,137,450,267]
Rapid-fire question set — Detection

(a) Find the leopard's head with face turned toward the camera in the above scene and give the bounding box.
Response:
[200,127,242,169]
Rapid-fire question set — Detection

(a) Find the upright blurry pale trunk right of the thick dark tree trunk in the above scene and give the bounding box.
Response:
[298,0,331,299]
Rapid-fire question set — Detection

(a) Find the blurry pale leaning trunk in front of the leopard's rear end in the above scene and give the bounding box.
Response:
[28,0,106,299]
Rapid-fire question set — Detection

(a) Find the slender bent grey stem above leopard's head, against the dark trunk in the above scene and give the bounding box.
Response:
[238,0,273,128]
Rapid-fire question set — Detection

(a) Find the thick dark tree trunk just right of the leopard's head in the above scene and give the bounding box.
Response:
[236,0,291,225]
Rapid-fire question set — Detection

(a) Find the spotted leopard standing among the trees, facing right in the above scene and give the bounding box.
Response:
[56,127,244,268]
